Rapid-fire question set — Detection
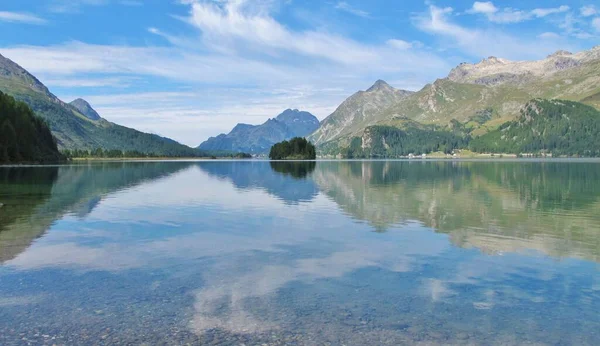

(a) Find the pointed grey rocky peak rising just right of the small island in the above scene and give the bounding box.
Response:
[310,80,412,144]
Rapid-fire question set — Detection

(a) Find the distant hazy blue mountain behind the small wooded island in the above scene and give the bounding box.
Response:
[198,109,319,154]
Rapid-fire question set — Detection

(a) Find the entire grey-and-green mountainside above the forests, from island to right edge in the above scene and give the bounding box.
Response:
[310,46,600,154]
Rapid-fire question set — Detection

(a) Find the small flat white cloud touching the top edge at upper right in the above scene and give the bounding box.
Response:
[467,1,569,24]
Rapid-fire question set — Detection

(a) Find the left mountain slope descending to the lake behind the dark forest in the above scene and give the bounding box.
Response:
[0,55,198,156]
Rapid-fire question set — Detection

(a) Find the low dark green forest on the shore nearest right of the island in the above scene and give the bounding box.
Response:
[342,126,470,158]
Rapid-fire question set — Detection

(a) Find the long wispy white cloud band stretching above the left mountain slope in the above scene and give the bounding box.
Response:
[2,42,294,83]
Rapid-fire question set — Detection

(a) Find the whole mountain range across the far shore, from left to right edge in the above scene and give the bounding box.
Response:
[0,46,600,157]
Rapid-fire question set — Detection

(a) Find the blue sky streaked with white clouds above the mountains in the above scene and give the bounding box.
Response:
[0,0,600,146]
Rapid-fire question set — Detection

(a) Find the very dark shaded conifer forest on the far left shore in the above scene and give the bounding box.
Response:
[0,92,64,163]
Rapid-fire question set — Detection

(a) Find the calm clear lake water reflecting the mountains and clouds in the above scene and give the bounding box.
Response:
[0,161,600,345]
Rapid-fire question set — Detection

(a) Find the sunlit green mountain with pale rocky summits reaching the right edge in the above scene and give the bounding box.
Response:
[378,47,600,134]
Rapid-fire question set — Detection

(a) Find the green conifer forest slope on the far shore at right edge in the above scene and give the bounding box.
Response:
[469,99,600,157]
